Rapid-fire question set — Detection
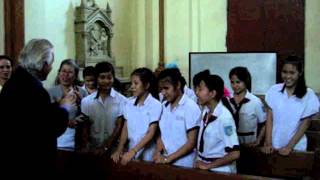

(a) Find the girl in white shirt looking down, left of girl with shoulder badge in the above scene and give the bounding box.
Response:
[153,69,201,167]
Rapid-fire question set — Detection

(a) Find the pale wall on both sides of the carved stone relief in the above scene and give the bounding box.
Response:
[25,0,133,87]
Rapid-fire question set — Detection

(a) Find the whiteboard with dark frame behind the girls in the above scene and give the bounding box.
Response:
[189,52,277,95]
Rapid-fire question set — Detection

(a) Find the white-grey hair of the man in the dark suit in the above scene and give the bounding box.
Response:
[19,39,54,76]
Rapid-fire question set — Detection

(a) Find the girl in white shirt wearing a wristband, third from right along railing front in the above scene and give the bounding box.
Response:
[111,68,162,165]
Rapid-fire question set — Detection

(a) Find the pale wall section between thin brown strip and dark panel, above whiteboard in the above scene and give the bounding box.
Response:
[165,0,227,82]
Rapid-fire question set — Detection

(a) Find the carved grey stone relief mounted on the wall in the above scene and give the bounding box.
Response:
[75,0,115,68]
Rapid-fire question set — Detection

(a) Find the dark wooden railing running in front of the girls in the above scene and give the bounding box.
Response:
[58,148,320,180]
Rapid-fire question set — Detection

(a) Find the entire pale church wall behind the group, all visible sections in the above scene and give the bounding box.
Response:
[24,0,320,92]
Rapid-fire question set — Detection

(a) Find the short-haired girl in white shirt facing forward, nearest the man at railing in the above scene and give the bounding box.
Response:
[81,61,127,155]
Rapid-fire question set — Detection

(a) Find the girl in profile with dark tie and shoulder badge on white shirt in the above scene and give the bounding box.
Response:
[194,75,240,173]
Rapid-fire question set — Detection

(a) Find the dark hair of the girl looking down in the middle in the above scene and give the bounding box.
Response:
[158,68,186,93]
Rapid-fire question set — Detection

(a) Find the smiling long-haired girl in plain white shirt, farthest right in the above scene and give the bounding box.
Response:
[263,56,319,155]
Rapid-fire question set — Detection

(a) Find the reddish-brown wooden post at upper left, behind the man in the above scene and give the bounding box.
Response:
[4,0,24,64]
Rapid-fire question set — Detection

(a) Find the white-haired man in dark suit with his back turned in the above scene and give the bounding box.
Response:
[0,39,70,179]
